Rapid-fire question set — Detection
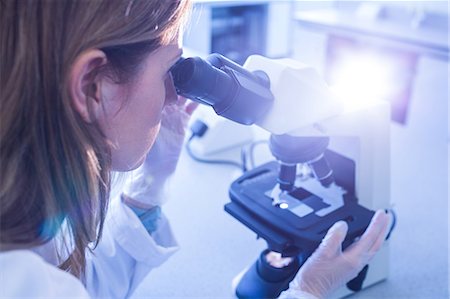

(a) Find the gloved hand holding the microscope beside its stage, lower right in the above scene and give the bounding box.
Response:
[286,210,390,298]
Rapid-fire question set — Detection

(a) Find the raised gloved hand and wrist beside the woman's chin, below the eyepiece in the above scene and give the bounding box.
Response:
[123,97,198,209]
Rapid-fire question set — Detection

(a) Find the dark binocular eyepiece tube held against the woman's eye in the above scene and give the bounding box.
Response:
[171,54,273,125]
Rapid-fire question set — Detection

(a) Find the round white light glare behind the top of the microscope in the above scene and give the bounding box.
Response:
[330,52,395,105]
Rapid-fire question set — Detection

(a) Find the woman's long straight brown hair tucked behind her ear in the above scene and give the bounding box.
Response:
[0,0,189,277]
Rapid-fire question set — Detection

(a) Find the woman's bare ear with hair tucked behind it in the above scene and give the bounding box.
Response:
[69,49,107,123]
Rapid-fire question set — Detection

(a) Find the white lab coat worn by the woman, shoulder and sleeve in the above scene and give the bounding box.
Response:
[0,198,178,298]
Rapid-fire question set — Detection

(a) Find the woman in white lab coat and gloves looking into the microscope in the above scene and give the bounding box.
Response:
[0,0,388,298]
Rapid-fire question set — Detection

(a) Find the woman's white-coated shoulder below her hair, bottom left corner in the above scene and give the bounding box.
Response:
[0,250,89,298]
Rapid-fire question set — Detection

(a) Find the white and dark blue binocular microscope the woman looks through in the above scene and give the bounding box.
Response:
[171,54,390,298]
